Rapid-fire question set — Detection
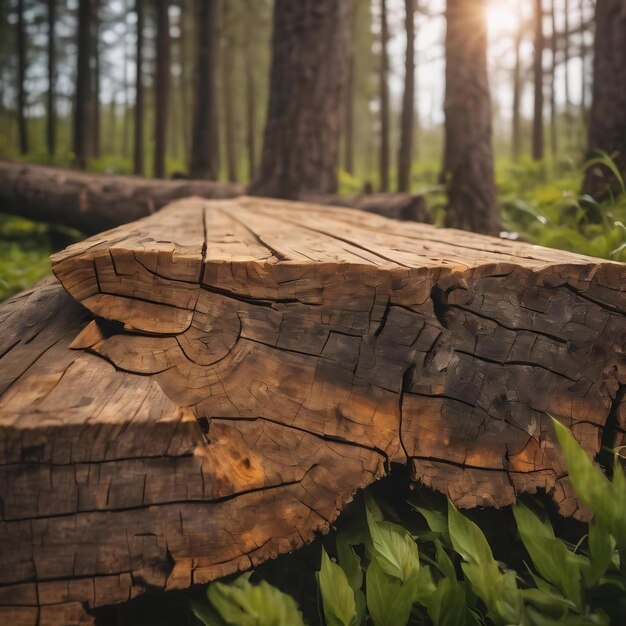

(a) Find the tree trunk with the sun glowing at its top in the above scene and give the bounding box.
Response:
[444,0,499,234]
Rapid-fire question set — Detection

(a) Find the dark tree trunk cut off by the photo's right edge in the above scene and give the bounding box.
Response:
[584,0,626,198]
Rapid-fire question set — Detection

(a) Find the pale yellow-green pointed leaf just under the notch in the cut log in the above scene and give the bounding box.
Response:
[366,502,419,582]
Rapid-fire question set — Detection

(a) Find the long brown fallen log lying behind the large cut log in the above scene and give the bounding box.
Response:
[0,160,431,235]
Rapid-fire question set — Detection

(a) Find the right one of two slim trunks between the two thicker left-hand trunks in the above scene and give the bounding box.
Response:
[154,0,171,178]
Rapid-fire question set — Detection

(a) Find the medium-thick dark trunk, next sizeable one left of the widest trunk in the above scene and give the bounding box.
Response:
[189,0,220,180]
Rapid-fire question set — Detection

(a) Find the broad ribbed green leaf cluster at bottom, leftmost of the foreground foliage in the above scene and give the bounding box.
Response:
[207,574,304,626]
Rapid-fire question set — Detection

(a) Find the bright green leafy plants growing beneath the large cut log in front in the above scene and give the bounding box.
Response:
[194,422,626,626]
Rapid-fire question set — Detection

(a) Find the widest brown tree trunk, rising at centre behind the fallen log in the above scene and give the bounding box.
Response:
[251,0,352,198]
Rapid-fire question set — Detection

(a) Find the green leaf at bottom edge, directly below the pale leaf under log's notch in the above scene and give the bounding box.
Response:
[366,559,417,626]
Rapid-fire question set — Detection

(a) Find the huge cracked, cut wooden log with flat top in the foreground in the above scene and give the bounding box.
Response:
[0,197,626,625]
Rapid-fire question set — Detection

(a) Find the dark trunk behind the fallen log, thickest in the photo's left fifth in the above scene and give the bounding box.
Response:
[73,0,94,169]
